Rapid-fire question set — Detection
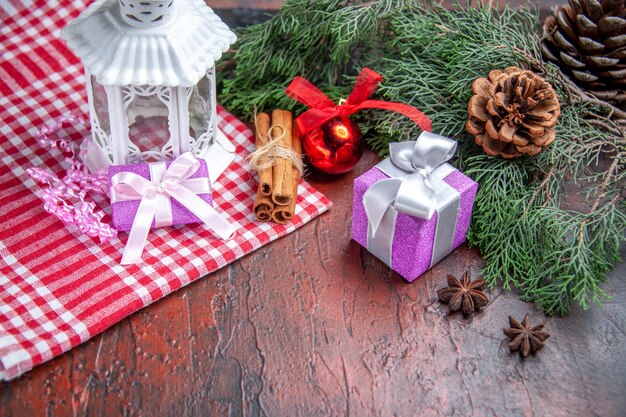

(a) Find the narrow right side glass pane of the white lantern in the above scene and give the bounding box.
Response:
[189,73,215,146]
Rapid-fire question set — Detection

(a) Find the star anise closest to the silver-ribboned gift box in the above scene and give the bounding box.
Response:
[437,271,489,314]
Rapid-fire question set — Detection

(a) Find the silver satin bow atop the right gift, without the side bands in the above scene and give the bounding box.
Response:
[363,132,457,236]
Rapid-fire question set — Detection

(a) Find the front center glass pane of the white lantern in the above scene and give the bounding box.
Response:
[126,87,170,161]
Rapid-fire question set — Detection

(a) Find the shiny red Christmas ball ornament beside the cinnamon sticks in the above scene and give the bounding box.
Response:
[302,116,364,174]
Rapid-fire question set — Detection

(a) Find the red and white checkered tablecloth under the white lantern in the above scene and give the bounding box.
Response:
[0,0,331,380]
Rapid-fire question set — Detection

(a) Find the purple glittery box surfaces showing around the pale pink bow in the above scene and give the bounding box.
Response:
[109,159,213,231]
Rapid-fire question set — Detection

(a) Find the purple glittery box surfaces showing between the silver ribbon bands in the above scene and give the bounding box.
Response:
[352,167,478,282]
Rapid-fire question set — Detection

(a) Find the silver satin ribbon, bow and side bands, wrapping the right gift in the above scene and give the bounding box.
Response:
[363,132,460,266]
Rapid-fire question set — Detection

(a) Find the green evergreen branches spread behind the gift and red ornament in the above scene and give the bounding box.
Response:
[221,0,626,314]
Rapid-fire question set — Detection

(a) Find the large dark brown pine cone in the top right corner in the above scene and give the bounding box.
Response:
[542,0,626,105]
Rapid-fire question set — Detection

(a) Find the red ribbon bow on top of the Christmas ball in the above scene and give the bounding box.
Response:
[286,68,432,134]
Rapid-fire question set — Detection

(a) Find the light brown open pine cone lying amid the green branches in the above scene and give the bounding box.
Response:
[465,67,561,158]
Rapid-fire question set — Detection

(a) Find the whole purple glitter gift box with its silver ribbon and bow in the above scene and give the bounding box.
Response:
[352,132,478,282]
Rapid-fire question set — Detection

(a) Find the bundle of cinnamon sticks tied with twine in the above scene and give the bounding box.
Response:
[249,110,304,224]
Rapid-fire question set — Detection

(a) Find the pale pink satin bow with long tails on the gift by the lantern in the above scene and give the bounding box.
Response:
[111,152,235,265]
